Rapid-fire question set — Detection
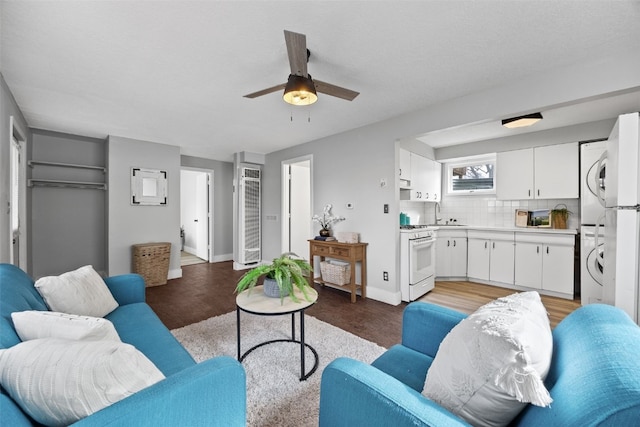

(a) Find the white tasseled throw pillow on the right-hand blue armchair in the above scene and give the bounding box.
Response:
[422,292,553,426]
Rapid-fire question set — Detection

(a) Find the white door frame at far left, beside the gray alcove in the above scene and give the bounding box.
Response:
[9,116,29,271]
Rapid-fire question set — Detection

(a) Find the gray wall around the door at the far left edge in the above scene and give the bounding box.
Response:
[0,73,31,263]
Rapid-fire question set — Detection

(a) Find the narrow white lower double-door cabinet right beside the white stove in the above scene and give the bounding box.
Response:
[436,229,467,278]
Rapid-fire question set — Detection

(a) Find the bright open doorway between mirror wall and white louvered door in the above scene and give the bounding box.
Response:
[180,169,213,265]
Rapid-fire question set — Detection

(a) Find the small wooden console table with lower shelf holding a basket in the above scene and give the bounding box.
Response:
[309,239,368,303]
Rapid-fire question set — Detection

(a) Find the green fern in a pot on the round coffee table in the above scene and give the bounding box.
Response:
[236,252,311,302]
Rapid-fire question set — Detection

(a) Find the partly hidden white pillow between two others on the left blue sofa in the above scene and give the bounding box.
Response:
[11,310,120,341]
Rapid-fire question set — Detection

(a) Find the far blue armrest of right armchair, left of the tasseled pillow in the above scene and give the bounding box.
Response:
[402,302,467,357]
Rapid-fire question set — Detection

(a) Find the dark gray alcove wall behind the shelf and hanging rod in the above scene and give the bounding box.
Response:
[27,129,107,278]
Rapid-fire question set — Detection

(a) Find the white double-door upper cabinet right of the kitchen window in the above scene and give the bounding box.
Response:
[496,142,580,200]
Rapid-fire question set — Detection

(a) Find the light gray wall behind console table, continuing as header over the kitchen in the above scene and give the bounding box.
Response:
[263,48,640,304]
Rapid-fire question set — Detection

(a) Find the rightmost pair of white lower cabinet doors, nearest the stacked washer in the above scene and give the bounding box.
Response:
[515,233,575,298]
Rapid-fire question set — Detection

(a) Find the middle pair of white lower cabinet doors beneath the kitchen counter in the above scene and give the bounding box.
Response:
[467,230,514,285]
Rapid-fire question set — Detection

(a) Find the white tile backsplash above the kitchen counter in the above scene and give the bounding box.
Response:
[398,196,580,229]
